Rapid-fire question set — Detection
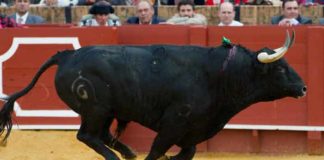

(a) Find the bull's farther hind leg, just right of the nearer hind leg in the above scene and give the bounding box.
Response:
[102,118,136,159]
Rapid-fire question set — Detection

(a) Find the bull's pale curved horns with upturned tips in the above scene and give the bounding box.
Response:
[258,31,295,63]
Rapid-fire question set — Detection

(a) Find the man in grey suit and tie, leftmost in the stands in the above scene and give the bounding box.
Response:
[9,0,45,24]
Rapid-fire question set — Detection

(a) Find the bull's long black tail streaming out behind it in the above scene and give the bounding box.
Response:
[0,51,71,144]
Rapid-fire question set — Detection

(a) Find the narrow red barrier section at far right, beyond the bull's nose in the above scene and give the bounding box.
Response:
[306,27,324,154]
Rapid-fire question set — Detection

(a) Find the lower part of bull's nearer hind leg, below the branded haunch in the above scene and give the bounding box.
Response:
[77,114,120,160]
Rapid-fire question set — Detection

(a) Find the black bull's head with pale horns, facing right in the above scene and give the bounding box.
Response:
[253,31,306,100]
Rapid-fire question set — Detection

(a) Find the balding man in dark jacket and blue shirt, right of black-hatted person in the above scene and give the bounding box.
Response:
[126,0,165,25]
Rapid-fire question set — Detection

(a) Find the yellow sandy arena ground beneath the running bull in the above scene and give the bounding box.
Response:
[0,130,324,160]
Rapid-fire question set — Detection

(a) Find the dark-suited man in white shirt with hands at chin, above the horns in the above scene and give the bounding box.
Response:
[271,0,312,26]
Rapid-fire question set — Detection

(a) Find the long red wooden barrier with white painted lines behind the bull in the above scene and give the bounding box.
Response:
[0,25,324,154]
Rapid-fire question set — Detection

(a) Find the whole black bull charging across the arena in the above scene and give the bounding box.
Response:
[0,32,306,160]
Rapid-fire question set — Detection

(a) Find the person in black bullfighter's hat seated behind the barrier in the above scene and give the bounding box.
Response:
[80,1,120,26]
